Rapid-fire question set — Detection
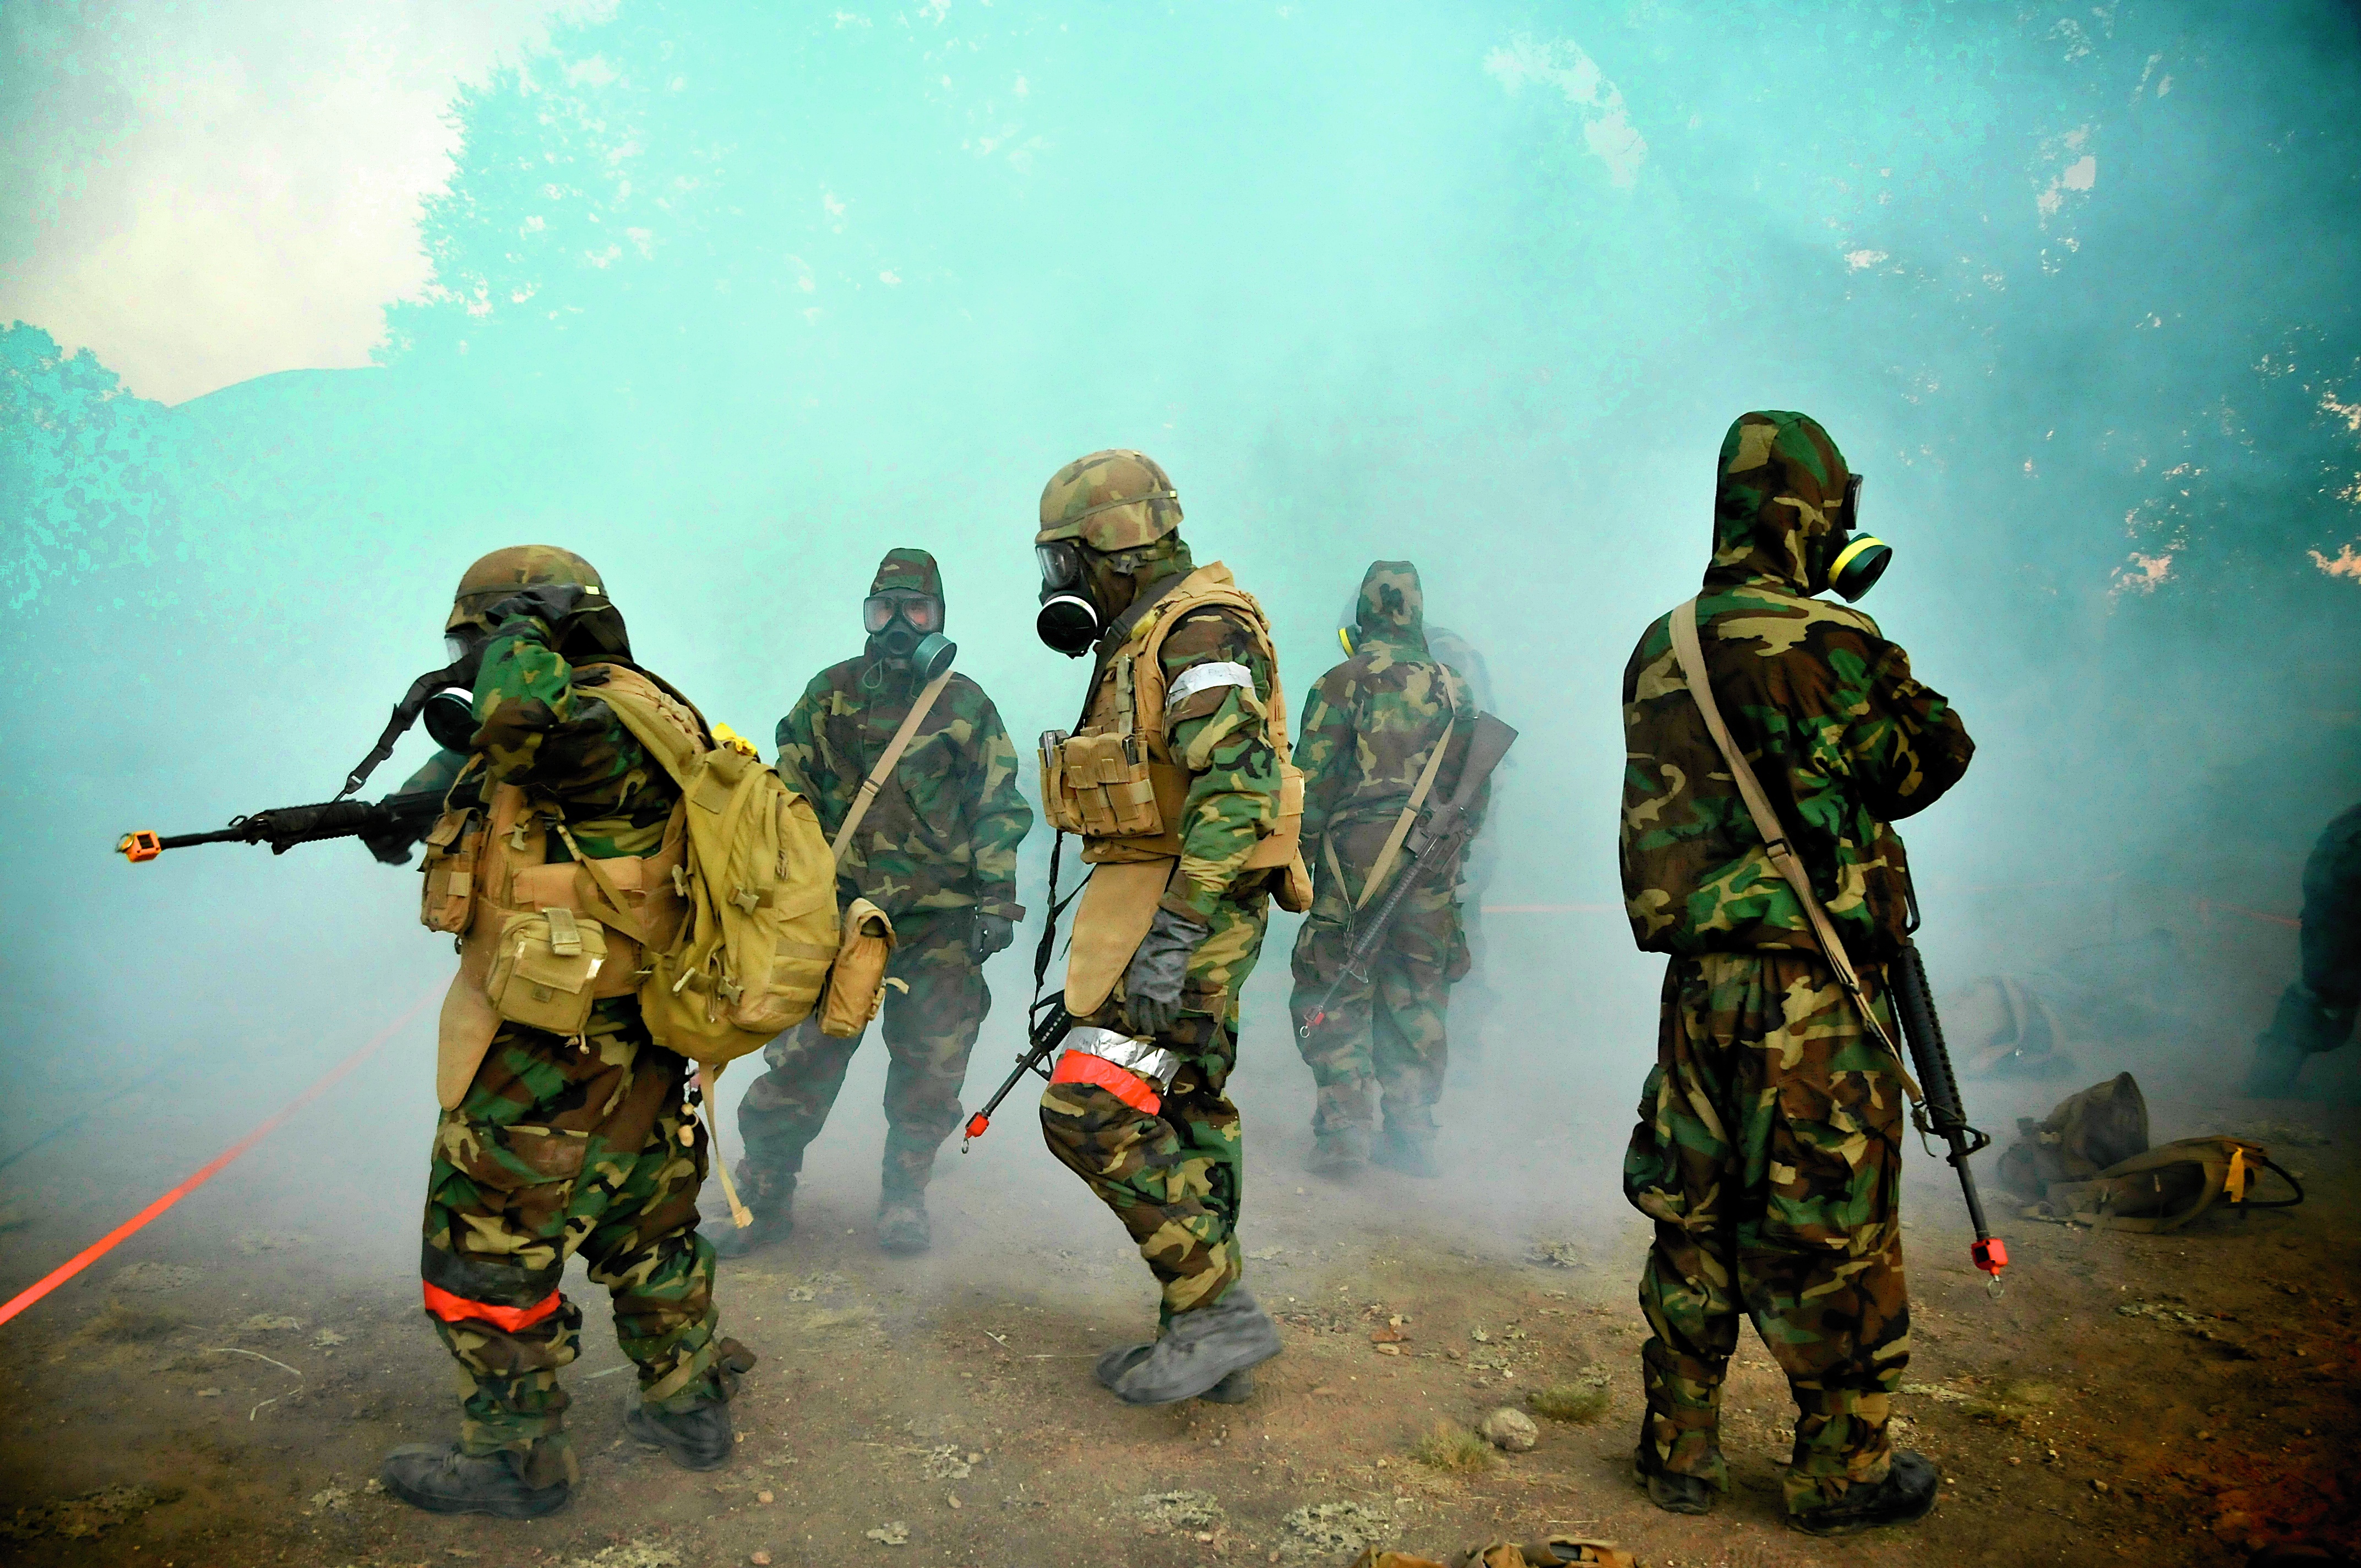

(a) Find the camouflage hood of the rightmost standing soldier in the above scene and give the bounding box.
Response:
[1705,409,1851,597]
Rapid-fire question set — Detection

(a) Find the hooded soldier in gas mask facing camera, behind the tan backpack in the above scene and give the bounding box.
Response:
[718,550,1032,1256]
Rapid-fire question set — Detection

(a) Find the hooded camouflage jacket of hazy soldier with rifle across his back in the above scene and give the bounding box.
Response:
[1294,560,1483,869]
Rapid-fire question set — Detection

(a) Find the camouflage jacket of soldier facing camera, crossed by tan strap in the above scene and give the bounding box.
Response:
[777,659,1032,921]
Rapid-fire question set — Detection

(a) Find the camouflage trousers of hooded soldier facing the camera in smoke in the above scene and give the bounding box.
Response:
[737,909,992,1209]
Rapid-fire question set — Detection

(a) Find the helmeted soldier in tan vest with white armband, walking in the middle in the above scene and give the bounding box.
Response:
[1034,451,1310,1405]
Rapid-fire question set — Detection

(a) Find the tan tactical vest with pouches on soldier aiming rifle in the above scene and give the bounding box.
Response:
[418,663,704,1110]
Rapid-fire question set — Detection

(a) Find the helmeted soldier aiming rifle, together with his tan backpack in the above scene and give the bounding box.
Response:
[373,546,788,1518]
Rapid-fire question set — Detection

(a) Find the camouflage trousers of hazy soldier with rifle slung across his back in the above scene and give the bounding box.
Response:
[1287,819,1466,1134]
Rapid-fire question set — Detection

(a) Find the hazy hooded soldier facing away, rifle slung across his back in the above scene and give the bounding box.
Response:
[1289,560,1483,1176]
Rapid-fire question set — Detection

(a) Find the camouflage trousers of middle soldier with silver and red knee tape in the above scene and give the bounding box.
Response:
[1041,885,1265,1322]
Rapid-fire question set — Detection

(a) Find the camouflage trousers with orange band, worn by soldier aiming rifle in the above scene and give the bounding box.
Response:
[420,997,727,1485]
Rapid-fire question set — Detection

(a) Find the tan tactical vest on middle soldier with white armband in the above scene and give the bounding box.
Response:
[1041,562,1310,1018]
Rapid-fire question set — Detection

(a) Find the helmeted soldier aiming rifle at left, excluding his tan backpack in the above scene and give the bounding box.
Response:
[387,546,753,1513]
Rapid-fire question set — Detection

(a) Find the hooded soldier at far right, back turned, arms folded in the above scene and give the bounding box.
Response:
[1622,413,1974,1533]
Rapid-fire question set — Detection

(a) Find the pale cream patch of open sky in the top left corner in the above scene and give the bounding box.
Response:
[0,0,592,404]
